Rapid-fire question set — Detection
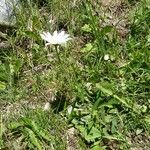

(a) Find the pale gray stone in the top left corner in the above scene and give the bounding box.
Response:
[0,0,18,25]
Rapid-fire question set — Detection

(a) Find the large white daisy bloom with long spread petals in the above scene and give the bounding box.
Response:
[40,31,72,46]
